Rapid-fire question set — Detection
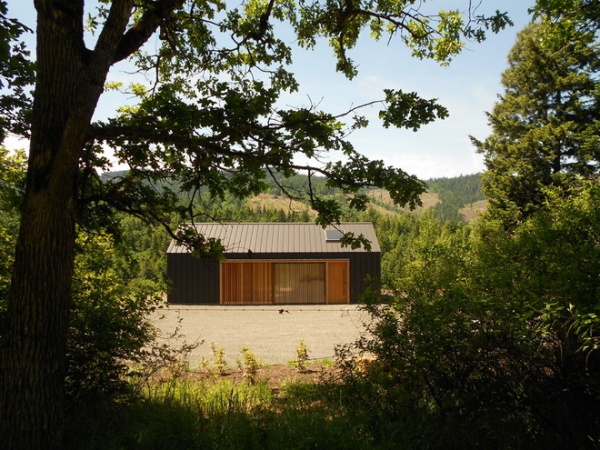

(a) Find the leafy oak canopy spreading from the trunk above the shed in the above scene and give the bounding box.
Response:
[65,0,510,254]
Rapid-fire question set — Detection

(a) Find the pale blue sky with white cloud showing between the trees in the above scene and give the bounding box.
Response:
[7,0,534,179]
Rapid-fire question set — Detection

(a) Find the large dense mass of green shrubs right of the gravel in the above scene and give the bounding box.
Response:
[341,178,600,448]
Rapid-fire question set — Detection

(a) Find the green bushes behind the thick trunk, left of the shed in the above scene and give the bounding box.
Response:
[0,149,170,404]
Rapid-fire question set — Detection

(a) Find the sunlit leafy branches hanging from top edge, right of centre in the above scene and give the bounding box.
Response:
[282,0,510,78]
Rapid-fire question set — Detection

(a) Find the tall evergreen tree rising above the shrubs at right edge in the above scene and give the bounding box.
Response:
[473,19,600,225]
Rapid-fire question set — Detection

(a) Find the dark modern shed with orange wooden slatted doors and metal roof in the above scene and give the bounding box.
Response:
[167,223,381,305]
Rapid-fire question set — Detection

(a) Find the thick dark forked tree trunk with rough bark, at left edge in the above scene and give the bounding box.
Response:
[0,0,131,450]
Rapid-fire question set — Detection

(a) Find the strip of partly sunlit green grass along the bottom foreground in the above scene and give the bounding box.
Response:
[65,362,584,450]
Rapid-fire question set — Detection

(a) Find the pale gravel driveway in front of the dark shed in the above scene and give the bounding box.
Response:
[155,305,368,367]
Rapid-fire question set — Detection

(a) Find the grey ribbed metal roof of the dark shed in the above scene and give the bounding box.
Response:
[167,222,381,253]
